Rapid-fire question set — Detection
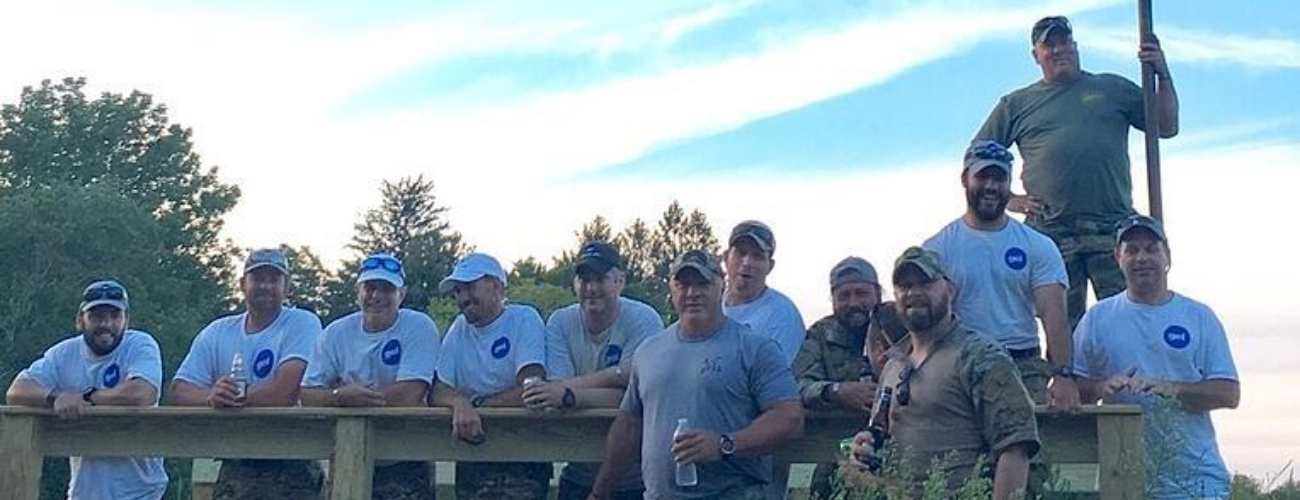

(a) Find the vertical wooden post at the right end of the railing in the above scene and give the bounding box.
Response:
[1097,414,1147,500]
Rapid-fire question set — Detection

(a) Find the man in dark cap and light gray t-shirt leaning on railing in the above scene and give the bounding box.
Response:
[524,242,663,500]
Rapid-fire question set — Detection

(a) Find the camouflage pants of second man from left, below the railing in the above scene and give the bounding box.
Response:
[212,460,321,500]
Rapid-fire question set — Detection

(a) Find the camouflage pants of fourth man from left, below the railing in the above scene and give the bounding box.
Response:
[456,462,551,500]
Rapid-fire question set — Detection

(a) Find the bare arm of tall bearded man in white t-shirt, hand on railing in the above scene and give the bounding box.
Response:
[1034,283,1079,412]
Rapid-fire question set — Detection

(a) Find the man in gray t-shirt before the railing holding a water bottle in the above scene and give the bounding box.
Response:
[590,251,803,499]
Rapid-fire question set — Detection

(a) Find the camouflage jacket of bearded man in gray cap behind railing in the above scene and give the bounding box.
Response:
[793,316,871,408]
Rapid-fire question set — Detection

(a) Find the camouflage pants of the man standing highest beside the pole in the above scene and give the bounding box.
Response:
[1034,216,1125,330]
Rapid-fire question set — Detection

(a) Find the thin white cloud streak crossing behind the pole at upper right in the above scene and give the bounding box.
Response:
[1078,27,1300,69]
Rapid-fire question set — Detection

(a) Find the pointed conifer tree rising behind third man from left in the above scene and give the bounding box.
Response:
[329,175,471,317]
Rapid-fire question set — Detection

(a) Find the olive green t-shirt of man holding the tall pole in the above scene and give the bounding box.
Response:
[975,71,1145,229]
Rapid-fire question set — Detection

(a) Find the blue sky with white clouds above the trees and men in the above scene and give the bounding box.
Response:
[0,0,1300,475]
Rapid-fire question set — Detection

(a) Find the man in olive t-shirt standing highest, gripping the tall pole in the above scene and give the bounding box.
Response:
[975,17,1178,327]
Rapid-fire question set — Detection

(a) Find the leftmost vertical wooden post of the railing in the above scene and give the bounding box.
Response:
[0,414,42,500]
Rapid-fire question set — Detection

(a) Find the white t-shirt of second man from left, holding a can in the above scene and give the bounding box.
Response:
[176,303,321,388]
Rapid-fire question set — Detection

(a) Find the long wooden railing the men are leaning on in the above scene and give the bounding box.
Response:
[0,405,1144,500]
